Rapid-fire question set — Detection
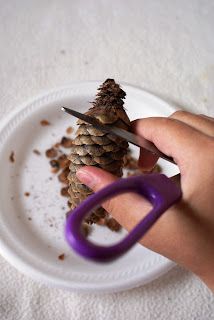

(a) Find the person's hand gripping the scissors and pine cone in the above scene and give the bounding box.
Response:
[77,111,214,289]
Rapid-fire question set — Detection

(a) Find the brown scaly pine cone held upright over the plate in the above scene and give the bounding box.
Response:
[68,79,130,223]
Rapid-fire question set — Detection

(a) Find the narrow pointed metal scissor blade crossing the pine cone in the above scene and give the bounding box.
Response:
[61,107,175,164]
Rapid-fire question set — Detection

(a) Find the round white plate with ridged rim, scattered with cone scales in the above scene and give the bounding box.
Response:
[0,82,177,292]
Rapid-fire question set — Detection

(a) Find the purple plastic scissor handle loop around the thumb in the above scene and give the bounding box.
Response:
[65,173,181,262]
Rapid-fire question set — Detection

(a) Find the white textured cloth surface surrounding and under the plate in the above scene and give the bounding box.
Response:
[0,0,214,320]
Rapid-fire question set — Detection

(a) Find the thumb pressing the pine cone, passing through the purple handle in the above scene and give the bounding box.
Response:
[77,166,151,230]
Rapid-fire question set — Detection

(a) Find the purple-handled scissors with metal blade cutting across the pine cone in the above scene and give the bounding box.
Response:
[61,107,182,262]
